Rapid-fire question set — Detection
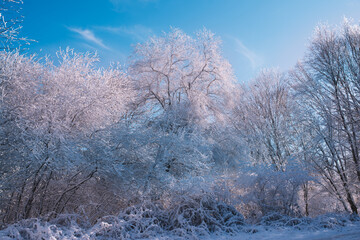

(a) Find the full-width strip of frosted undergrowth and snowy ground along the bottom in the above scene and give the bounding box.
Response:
[0,197,360,240]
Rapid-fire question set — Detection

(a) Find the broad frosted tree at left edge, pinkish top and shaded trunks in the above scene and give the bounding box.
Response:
[0,49,134,223]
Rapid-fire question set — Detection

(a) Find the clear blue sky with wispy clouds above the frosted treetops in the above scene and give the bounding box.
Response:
[22,0,360,81]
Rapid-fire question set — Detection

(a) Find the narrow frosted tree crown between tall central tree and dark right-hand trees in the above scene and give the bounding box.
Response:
[234,70,297,171]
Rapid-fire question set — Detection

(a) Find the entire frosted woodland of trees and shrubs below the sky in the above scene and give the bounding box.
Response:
[0,0,360,239]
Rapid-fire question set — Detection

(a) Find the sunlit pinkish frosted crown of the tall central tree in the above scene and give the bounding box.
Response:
[129,29,235,126]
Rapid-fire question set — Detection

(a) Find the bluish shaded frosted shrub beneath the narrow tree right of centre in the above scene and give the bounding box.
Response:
[237,166,309,222]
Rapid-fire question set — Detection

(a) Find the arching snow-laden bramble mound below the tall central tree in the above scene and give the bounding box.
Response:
[89,197,245,238]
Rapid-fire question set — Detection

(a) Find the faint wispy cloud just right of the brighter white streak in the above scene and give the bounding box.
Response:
[102,25,154,41]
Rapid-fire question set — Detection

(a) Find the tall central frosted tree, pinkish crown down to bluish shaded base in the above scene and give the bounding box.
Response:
[124,29,242,197]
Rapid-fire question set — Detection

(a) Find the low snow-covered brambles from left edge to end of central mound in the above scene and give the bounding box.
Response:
[0,196,247,240]
